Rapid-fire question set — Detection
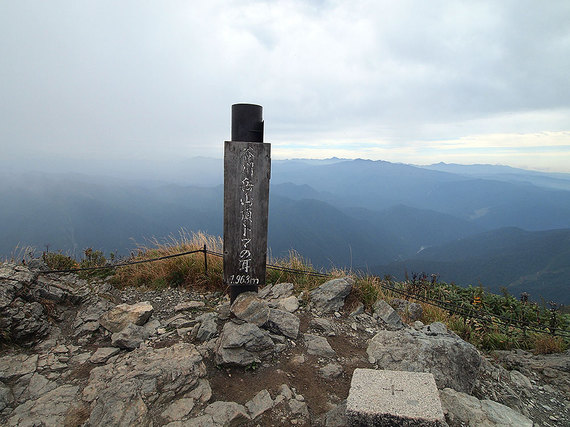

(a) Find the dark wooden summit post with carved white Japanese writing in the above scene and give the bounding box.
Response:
[224,104,271,303]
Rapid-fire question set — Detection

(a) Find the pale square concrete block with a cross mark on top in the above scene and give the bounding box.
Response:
[346,369,447,426]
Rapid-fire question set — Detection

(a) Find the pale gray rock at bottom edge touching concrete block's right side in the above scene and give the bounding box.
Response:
[439,388,533,427]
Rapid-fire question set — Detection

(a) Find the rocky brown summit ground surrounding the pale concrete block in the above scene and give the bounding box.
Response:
[0,262,570,427]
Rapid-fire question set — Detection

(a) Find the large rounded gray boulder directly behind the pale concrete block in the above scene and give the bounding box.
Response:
[366,329,481,393]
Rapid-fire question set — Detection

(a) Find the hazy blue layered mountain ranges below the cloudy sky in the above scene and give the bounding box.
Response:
[0,158,570,303]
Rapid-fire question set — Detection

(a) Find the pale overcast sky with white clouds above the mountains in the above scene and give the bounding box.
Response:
[0,0,570,172]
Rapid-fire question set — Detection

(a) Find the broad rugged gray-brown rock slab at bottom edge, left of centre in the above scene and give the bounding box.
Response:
[83,343,206,426]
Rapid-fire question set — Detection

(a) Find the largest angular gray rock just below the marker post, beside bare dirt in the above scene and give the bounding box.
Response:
[215,322,274,366]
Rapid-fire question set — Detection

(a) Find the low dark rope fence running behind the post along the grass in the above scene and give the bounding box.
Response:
[40,245,570,338]
